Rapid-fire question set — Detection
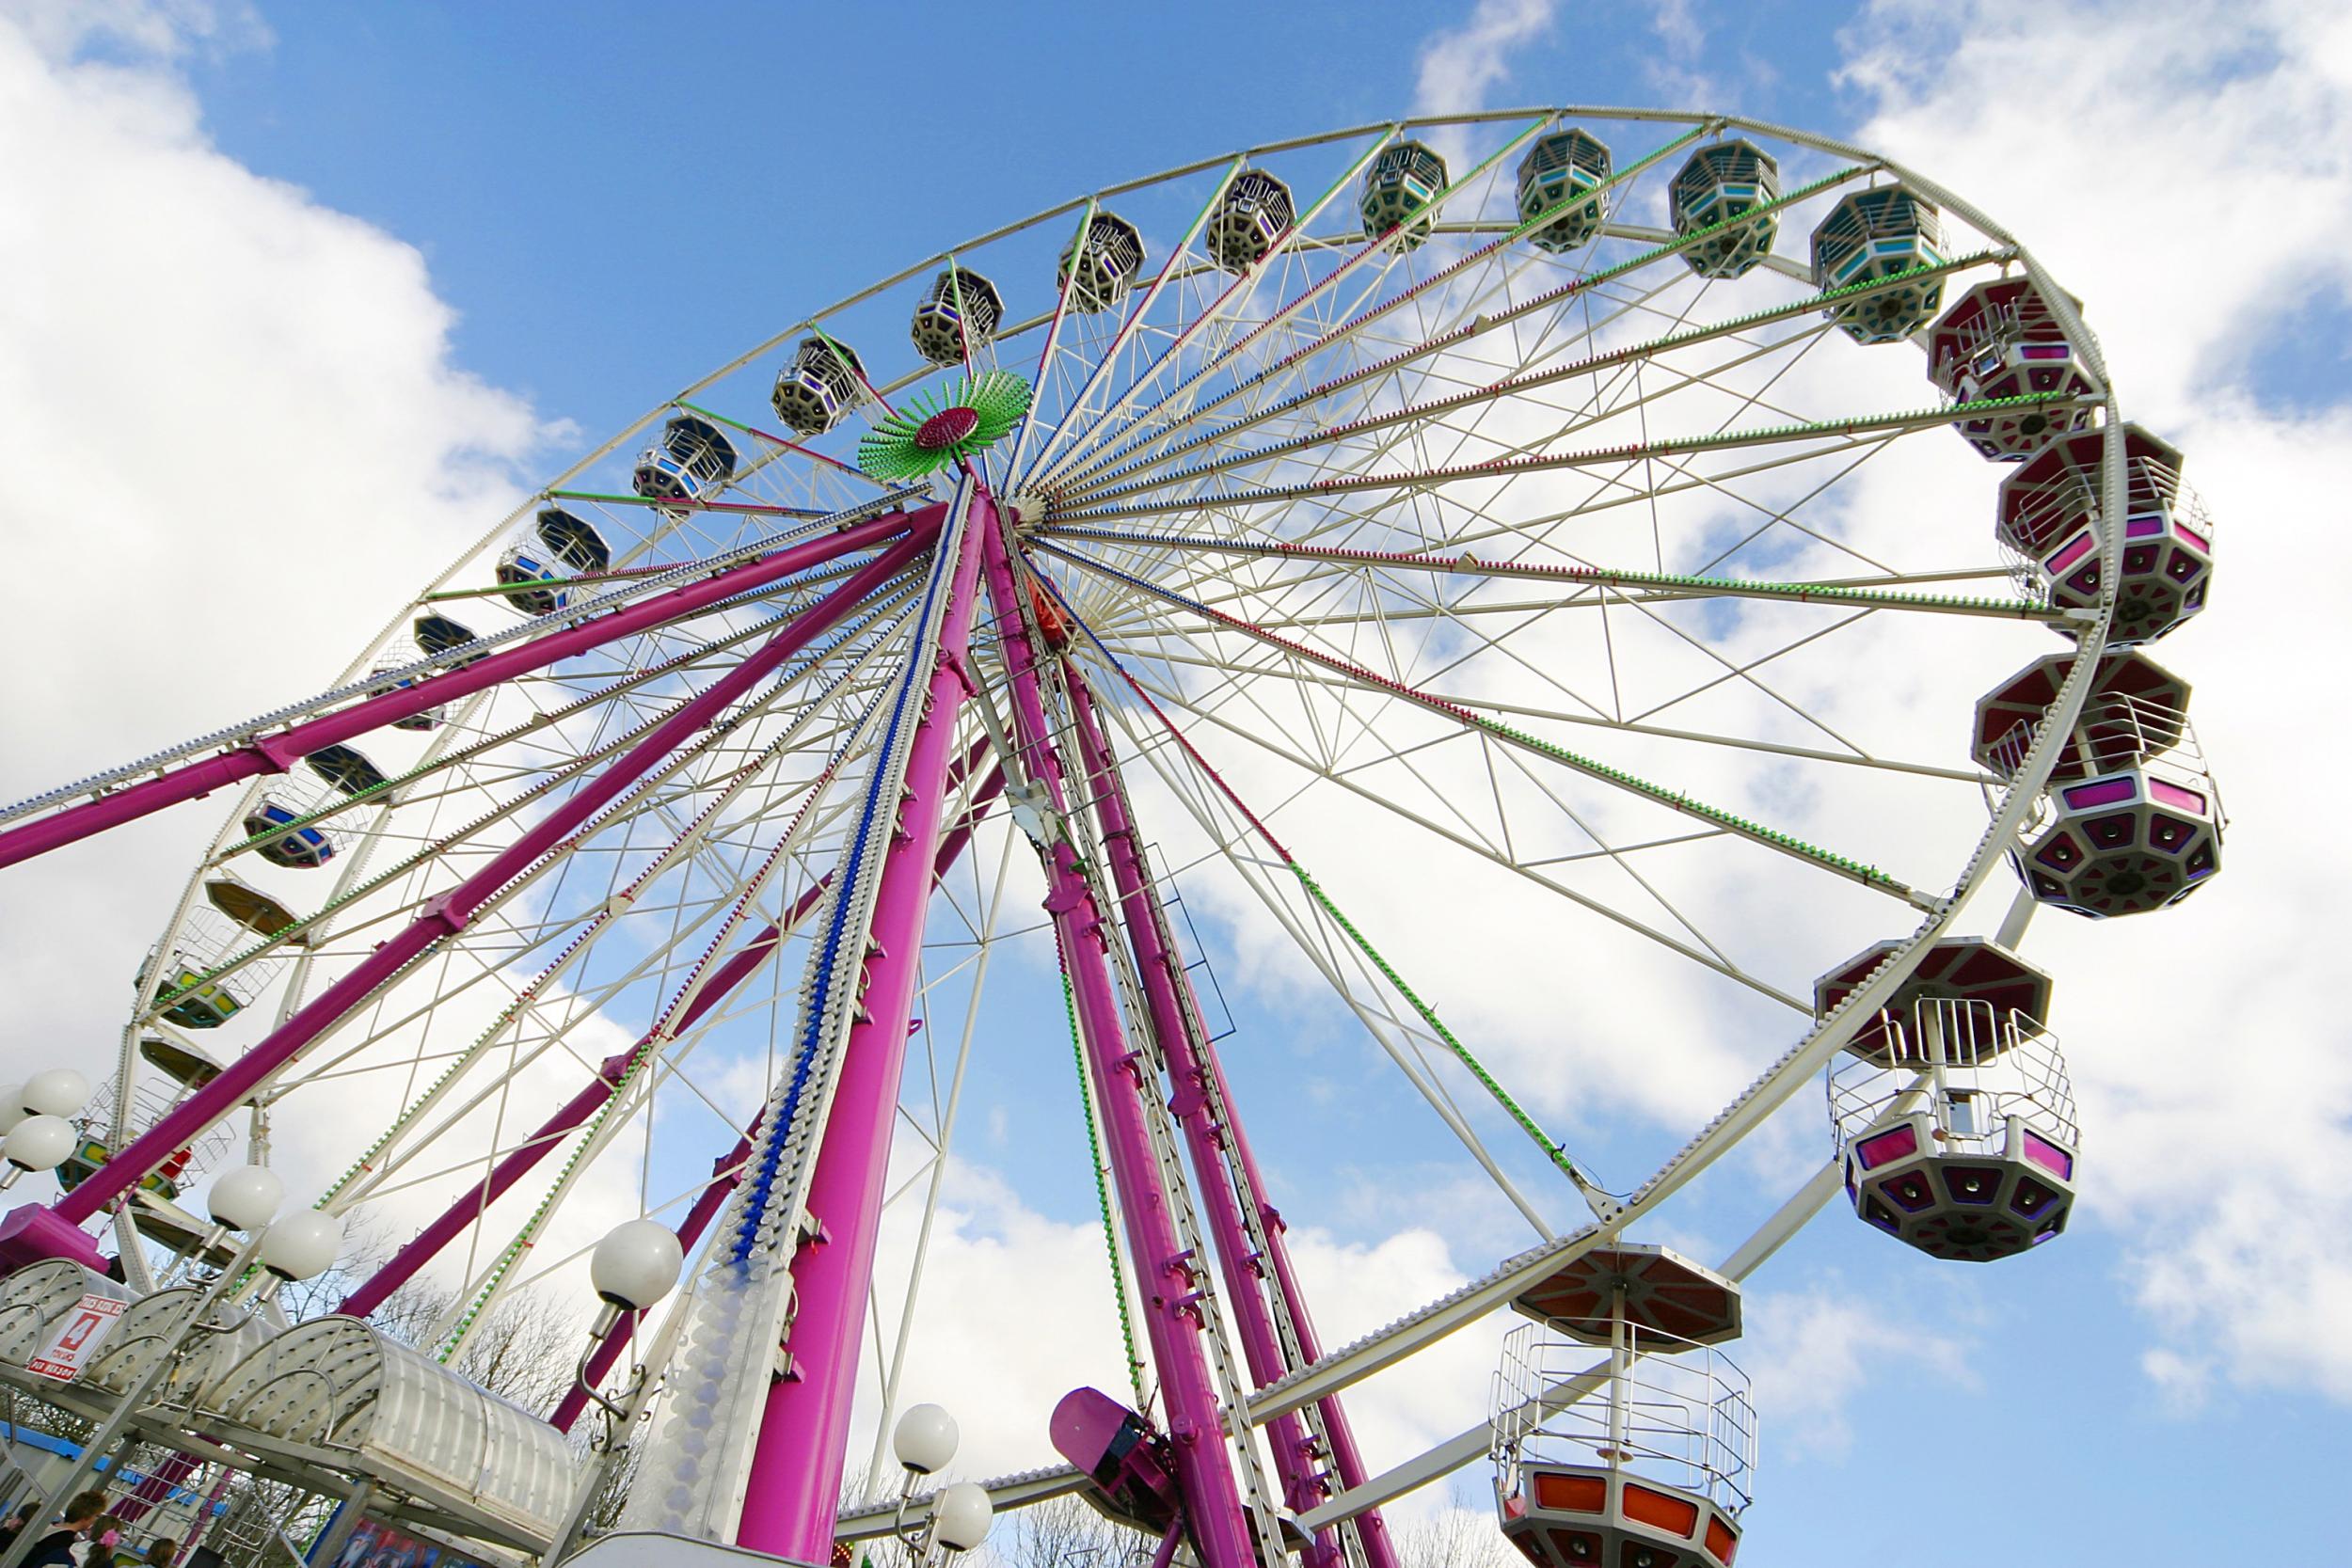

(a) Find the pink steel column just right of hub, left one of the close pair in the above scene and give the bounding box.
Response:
[981,515,1259,1568]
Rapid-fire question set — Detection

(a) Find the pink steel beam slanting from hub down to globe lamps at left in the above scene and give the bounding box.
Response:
[0,526,930,1267]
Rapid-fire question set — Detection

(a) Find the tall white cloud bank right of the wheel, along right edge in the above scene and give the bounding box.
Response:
[1844,0,2352,1403]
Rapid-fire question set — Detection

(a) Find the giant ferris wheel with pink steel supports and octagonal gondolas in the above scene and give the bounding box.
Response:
[0,108,2223,1568]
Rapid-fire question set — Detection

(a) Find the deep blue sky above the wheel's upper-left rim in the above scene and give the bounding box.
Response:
[170,5,1839,444]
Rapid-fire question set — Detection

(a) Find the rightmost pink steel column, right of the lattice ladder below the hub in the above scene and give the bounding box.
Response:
[1068,670,1397,1568]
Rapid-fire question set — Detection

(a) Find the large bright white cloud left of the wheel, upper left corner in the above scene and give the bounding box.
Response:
[0,0,566,1278]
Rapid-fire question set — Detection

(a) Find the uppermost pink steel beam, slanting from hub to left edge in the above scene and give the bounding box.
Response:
[0,505,944,867]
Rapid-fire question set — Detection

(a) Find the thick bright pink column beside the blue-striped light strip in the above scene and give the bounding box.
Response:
[737,484,995,1563]
